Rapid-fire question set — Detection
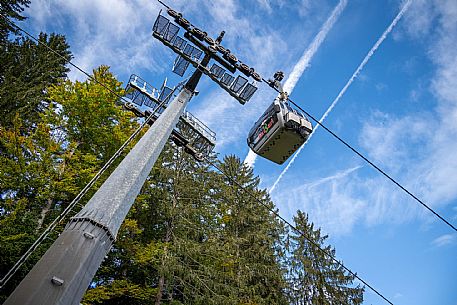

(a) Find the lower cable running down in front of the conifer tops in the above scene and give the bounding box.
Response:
[206,158,393,305]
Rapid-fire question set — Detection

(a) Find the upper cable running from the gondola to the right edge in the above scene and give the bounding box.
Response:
[262,79,457,232]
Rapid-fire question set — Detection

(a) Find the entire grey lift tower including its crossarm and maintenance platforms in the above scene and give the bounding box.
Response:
[4,5,261,305]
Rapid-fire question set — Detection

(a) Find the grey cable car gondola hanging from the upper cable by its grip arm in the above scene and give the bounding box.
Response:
[247,72,313,164]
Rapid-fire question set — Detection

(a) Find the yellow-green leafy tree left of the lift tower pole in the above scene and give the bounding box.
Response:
[0,66,137,300]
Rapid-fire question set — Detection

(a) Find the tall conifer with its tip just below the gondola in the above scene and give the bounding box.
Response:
[218,156,285,304]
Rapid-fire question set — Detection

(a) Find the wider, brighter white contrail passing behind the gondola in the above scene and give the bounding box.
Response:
[244,0,347,167]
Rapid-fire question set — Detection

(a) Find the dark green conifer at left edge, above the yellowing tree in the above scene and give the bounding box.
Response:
[0,33,71,127]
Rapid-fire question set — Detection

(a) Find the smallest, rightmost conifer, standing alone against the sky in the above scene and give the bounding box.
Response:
[286,211,364,305]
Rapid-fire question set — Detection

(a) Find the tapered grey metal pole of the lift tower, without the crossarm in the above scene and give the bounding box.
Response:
[4,86,194,305]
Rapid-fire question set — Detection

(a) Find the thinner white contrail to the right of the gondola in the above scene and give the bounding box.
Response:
[268,0,412,194]
